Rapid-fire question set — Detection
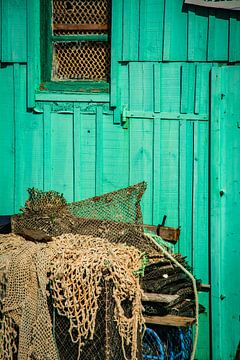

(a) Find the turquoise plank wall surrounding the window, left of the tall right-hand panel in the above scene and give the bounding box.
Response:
[0,0,240,360]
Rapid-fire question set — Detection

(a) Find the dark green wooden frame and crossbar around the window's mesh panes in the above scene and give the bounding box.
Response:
[40,0,111,92]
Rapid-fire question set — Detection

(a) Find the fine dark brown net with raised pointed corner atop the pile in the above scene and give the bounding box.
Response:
[12,183,159,258]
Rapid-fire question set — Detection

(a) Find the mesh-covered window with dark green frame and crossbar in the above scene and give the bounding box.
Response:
[42,0,111,88]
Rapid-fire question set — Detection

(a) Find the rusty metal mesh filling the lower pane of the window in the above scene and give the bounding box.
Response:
[53,41,110,81]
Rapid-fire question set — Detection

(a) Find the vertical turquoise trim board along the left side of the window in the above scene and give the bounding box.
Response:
[27,0,40,108]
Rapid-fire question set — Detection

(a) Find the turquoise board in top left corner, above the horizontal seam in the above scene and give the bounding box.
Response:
[1,0,27,62]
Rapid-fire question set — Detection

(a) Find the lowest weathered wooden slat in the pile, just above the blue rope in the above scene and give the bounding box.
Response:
[144,315,195,327]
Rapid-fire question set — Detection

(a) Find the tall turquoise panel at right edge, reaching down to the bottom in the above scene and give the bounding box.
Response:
[210,67,240,360]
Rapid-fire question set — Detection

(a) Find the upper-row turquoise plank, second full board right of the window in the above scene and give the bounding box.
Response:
[139,0,164,61]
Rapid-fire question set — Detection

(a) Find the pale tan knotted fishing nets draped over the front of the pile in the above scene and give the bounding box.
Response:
[0,234,143,360]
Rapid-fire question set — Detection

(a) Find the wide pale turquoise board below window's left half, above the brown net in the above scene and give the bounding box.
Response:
[48,113,74,202]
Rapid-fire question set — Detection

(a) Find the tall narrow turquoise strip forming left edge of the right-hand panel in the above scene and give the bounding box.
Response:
[210,68,223,359]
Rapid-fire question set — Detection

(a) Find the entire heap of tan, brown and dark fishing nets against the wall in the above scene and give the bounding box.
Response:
[0,183,199,360]
